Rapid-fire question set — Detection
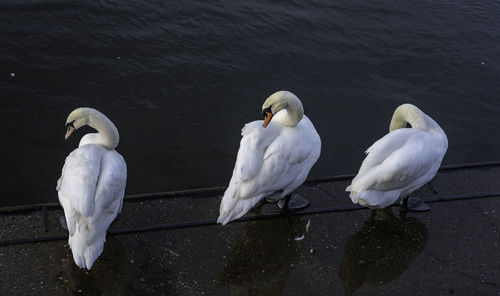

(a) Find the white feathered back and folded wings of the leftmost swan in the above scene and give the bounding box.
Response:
[58,145,127,269]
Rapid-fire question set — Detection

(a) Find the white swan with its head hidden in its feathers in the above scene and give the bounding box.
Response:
[346,104,448,208]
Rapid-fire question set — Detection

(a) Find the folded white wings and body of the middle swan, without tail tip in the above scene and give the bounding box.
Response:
[230,118,321,199]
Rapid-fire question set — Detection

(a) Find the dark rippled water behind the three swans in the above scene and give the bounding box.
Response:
[0,0,500,206]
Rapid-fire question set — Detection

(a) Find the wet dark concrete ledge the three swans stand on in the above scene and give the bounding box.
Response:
[0,162,500,295]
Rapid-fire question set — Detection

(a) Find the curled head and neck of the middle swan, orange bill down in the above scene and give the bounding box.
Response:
[262,90,304,127]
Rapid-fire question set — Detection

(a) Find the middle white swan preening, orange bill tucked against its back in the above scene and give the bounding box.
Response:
[217,91,321,225]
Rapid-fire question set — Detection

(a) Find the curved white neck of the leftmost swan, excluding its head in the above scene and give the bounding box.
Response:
[79,110,120,149]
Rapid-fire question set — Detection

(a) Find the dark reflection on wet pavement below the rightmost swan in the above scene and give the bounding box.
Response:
[339,208,429,295]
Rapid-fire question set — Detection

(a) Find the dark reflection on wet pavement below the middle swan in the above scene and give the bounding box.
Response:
[217,217,306,295]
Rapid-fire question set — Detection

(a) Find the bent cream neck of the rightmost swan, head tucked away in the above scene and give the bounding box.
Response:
[389,104,444,134]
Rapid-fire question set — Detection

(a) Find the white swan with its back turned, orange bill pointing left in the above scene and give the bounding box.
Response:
[57,108,127,269]
